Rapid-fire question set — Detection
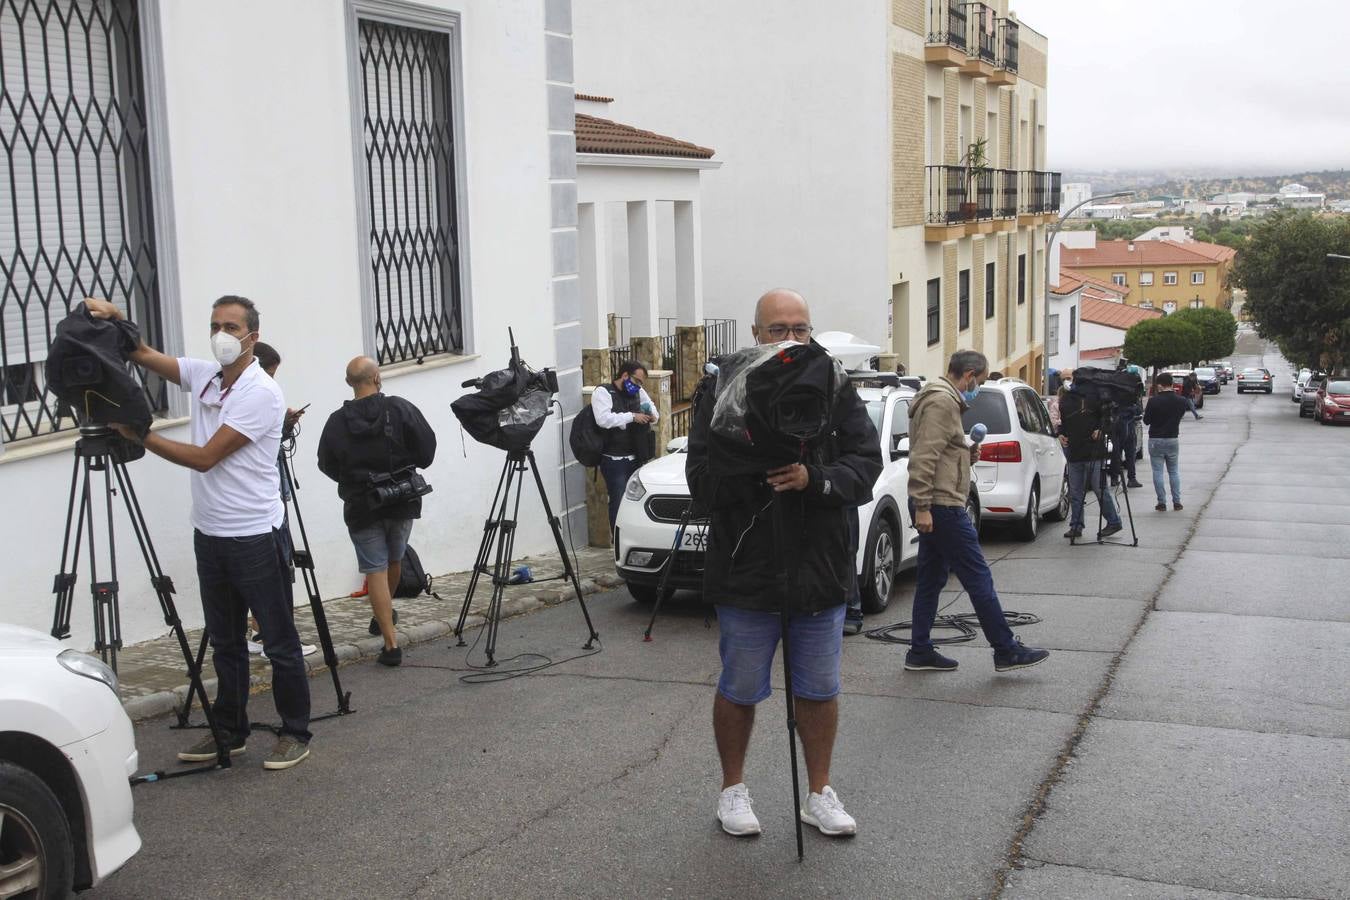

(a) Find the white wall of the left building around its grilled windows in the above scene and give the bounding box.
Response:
[0,0,567,646]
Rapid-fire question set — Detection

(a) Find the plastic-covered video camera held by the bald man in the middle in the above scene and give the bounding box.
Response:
[709,341,848,475]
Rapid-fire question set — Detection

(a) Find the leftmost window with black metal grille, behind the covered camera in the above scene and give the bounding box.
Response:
[0,0,167,443]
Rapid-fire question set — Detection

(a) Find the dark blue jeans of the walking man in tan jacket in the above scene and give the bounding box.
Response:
[910,505,1014,653]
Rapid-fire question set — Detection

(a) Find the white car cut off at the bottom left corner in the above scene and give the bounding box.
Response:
[0,625,140,897]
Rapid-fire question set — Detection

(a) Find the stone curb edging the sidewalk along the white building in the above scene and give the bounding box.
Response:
[122,575,624,722]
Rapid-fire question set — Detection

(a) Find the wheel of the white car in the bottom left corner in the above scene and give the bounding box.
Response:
[0,762,74,897]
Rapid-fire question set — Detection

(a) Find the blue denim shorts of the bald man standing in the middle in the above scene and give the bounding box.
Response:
[717,603,845,706]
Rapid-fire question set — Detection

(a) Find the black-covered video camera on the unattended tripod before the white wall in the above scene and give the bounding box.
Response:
[450,328,558,452]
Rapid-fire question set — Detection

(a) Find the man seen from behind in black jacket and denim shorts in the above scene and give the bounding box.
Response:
[319,356,436,665]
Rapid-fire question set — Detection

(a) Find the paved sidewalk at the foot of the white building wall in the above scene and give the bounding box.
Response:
[117,546,622,719]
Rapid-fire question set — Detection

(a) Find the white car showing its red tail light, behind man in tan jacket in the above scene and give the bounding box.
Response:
[961,378,1069,541]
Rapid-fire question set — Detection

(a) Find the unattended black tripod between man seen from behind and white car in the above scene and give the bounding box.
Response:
[455,449,599,667]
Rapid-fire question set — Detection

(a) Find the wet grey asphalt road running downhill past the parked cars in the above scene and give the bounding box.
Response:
[92,335,1350,899]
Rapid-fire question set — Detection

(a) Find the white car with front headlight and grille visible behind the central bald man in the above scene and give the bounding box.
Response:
[614,387,980,613]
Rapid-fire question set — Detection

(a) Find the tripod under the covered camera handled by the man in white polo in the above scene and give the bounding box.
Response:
[51,425,230,780]
